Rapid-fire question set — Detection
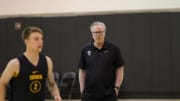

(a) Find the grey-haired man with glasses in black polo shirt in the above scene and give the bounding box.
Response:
[79,21,125,101]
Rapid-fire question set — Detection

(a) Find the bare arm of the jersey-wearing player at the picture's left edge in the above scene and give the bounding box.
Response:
[0,59,19,101]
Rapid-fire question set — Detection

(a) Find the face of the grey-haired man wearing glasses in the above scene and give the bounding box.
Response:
[91,25,105,43]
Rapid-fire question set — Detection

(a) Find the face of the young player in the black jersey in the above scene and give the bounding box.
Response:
[25,32,43,52]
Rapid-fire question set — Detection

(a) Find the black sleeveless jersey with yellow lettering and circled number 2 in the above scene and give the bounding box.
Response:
[9,54,48,101]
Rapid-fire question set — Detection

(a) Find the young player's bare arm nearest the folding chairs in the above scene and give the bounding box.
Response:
[46,57,62,101]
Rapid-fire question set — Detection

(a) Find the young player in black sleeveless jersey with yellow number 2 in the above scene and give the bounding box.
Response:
[0,27,61,101]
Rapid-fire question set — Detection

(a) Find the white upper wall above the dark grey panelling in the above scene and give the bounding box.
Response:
[0,0,180,17]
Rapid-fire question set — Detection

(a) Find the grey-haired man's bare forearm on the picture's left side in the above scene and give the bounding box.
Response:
[79,69,86,94]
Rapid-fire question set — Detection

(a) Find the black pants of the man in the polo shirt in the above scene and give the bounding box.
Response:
[81,96,118,101]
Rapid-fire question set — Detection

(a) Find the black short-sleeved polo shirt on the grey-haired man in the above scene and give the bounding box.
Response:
[79,41,125,97]
